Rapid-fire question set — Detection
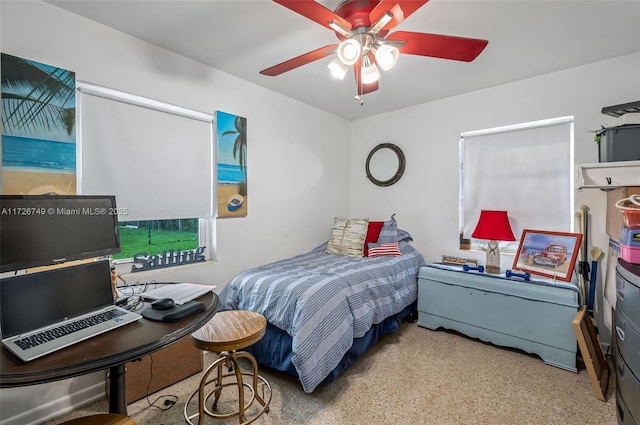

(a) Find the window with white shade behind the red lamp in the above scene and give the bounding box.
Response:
[459,117,574,253]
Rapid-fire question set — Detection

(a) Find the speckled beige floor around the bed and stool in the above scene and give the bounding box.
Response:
[45,322,617,425]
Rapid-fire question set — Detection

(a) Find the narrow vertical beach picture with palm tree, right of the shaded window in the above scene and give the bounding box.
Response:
[216,111,248,217]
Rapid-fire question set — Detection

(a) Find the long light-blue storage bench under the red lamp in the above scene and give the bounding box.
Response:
[418,264,580,372]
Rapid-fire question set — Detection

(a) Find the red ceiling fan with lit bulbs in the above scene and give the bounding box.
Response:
[260,0,488,99]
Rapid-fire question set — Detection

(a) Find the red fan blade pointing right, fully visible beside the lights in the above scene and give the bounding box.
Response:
[387,31,489,62]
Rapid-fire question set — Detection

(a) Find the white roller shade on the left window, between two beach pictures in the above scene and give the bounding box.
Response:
[78,83,214,221]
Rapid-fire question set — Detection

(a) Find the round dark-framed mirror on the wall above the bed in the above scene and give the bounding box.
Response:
[366,143,406,186]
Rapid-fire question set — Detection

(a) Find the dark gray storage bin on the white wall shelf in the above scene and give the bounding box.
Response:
[598,125,640,162]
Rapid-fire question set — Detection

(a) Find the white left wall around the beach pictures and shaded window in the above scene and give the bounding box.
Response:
[0,0,349,425]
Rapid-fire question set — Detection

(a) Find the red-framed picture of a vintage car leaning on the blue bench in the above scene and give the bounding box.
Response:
[513,229,582,282]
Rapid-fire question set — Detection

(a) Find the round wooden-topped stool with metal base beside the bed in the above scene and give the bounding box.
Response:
[184,310,271,425]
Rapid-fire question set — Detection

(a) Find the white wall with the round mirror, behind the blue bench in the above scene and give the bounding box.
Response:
[350,53,640,342]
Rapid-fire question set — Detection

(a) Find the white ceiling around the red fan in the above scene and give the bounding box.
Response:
[46,0,640,120]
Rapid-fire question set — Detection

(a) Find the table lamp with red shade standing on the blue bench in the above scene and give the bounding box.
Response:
[471,210,516,274]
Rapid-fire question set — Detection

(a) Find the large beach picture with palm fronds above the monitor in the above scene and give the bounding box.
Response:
[0,53,76,194]
